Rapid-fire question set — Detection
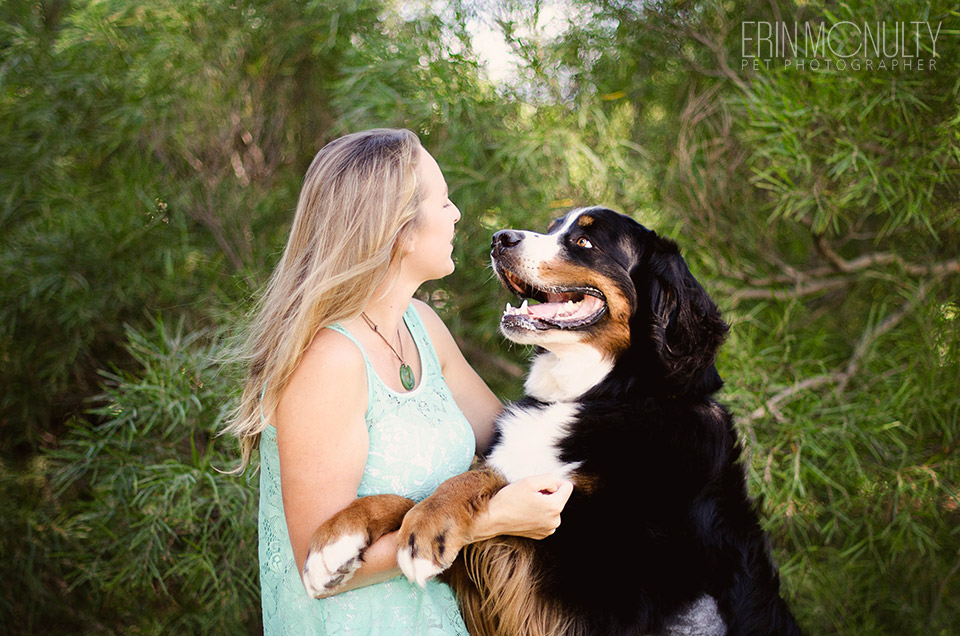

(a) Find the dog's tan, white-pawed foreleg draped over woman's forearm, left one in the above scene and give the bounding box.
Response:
[303,495,413,597]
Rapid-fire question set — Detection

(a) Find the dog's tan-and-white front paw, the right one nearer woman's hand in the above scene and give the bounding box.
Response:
[397,502,467,587]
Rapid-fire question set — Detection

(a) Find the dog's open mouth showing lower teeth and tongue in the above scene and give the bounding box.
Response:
[500,268,607,330]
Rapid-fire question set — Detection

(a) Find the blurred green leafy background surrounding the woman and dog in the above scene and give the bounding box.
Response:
[0,0,960,636]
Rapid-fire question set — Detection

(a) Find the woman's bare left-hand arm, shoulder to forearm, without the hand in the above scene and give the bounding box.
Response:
[276,329,400,592]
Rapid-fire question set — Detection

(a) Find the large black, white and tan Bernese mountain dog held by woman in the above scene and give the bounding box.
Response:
[304,207,800,636]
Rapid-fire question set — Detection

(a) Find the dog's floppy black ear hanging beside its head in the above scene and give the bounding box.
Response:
[635,236,729,390]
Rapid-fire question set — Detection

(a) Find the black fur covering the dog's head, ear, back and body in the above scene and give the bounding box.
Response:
[468,208,800,636]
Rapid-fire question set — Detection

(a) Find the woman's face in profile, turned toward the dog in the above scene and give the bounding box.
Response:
[402,148,460,281]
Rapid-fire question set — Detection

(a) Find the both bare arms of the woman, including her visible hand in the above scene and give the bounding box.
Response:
[276,301,572,593]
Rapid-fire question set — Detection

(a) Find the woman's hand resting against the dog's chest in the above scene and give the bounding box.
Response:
[472,473,573,542]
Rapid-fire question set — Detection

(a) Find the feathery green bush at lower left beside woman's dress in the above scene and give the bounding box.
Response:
[3,321,259,634]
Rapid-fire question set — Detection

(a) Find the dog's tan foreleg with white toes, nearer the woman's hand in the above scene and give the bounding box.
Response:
[397,468,507,586]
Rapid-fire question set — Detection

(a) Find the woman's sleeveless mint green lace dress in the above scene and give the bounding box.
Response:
[259,305,475,636]
